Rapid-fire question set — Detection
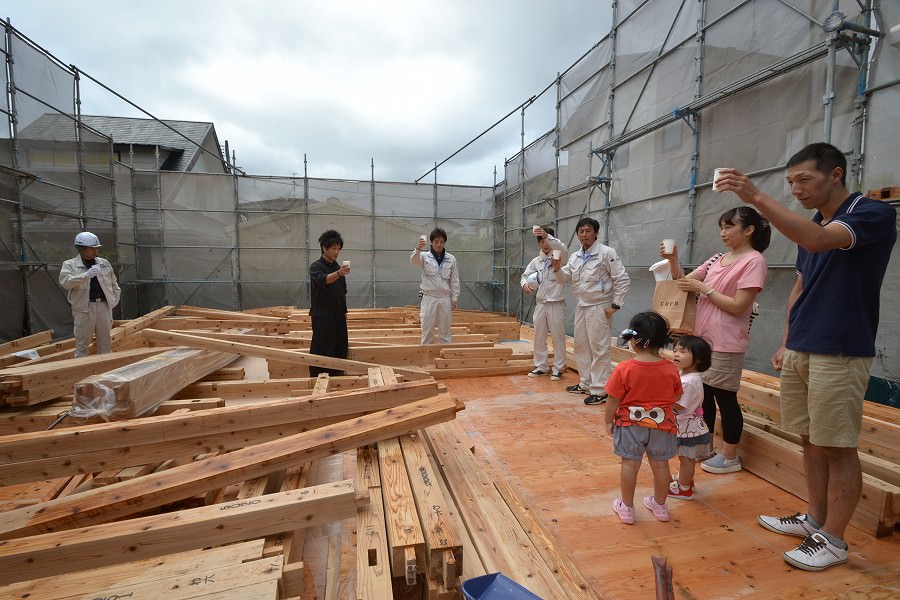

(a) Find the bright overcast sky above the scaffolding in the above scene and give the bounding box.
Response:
[2,0,612,185]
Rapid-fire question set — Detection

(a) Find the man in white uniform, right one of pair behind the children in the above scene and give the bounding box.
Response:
[556,217,631,404]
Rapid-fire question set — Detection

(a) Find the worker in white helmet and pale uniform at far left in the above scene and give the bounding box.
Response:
[59,231,122,358]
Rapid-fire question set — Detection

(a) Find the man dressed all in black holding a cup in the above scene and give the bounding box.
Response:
[309,229,350,377]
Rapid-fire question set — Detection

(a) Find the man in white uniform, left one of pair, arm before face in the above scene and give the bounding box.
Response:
[519,225,568,381]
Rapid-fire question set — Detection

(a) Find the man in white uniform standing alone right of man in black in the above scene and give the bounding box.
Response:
[409,227,459,346]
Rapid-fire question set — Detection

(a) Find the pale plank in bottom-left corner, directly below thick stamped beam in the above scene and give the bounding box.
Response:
[0,540,263,599]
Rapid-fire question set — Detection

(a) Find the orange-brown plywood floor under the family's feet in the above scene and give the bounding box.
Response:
[444,371,900,599]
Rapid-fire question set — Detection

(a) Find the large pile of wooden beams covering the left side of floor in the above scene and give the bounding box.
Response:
[0,307,595,600]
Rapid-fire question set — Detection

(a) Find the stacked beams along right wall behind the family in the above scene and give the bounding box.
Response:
[613,342,900,537]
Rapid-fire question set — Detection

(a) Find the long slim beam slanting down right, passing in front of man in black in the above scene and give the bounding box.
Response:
[144,329,427,379]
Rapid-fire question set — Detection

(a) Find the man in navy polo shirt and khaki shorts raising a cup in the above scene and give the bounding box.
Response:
[716,143,897,571]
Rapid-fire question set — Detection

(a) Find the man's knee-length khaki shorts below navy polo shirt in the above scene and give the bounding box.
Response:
[781,350,872,448]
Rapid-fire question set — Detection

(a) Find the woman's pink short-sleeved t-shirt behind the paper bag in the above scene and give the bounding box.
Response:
[694,250,769,353]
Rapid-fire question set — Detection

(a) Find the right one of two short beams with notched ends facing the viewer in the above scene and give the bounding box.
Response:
[399,434,463,586]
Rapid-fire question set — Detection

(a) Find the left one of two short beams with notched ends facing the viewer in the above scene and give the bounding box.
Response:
[378,438,426,582]
